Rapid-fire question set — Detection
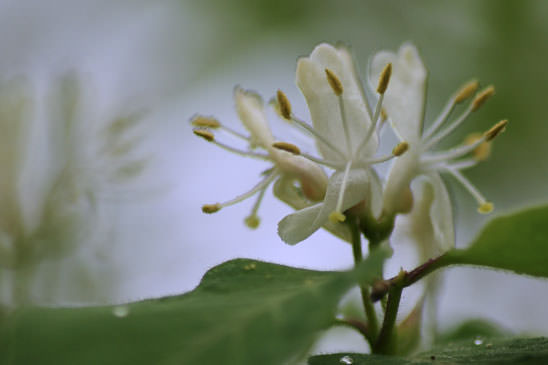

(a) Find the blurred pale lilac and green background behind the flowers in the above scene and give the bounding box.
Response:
[0,0,548,351]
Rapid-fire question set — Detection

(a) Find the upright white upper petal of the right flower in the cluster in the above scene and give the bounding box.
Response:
[369,43,427,143]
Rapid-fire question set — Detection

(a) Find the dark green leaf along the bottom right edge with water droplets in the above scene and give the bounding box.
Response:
[308,337,548,365]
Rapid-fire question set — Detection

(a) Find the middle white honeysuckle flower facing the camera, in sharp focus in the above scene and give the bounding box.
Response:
[278,44,407,244]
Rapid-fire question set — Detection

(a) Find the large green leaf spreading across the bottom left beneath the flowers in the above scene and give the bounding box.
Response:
[0,253,384,365]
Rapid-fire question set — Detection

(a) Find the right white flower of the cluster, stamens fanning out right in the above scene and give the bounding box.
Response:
[369,44,507,247]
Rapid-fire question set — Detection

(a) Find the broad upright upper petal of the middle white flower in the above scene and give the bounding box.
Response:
[297,44,378,161]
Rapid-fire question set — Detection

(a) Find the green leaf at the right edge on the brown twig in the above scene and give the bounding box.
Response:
[446,206,548,277]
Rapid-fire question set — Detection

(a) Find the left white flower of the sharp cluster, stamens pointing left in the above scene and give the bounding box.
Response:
[191,87,327,228]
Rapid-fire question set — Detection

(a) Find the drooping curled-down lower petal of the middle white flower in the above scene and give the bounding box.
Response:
[278,169,369,245]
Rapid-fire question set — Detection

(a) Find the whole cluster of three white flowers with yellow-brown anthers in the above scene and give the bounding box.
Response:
[192,44,507,251]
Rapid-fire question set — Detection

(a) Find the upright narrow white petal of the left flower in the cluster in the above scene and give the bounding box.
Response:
[234,87,274,150]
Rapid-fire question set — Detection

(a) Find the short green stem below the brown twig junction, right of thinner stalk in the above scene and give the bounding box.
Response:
[373,271,404,355]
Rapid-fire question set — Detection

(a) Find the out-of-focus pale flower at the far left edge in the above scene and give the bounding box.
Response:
[0,75,145,304]
